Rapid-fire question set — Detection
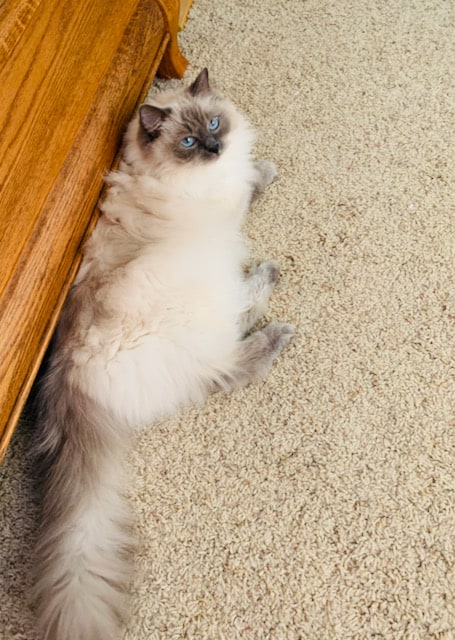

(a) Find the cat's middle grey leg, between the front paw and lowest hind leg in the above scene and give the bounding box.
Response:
[239,260,280,335]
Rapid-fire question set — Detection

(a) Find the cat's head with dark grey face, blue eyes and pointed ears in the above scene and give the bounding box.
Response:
[123,69,253,175]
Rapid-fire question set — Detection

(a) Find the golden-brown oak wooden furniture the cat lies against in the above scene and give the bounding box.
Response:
[0,0,191,460]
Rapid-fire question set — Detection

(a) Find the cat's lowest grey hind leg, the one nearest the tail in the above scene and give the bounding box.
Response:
[219,322,295,391]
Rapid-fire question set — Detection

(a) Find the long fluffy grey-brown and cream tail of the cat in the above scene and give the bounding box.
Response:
[34,387,131,640]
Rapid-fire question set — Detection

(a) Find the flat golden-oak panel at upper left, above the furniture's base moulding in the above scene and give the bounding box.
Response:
[0,0,136,296]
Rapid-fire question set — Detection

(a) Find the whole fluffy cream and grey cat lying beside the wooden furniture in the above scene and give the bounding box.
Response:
[34,69,294,640]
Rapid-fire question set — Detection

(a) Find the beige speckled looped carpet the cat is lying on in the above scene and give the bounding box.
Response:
[0,0,455,640]
